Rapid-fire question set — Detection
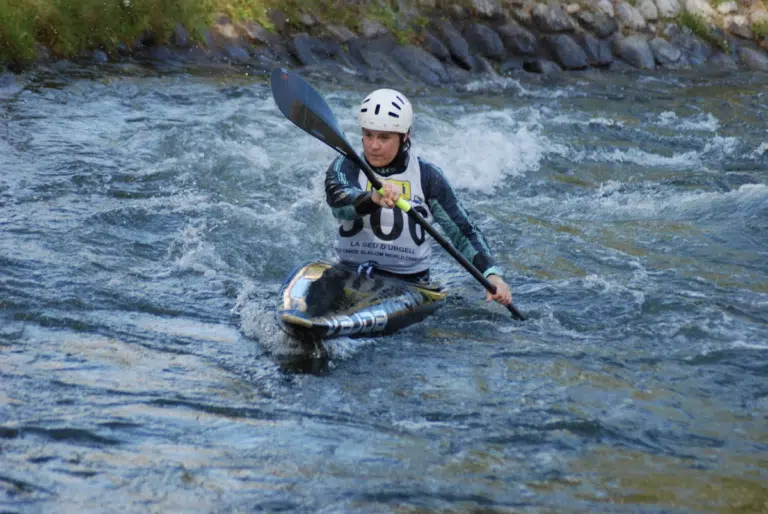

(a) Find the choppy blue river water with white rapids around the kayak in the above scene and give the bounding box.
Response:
[0,62,768,513]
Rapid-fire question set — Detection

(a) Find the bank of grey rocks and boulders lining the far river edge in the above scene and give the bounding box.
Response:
[1,0,768,81]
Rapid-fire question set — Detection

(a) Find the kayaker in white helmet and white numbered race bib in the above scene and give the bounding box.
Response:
[325,89,512,305]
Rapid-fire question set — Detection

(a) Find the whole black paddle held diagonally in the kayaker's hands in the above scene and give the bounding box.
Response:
[272,68,525,321]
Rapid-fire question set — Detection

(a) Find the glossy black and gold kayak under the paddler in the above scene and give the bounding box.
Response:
[277,261,446,340]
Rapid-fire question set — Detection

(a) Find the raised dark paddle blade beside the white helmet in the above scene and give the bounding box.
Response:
[272,68,357,157]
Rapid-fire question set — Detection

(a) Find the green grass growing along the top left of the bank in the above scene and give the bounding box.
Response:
[0,0,414,63]
